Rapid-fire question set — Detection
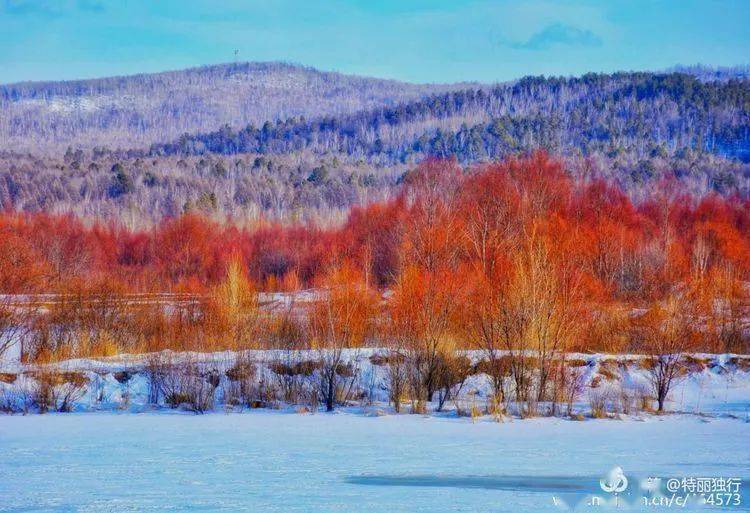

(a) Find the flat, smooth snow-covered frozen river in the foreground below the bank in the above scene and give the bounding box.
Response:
[0,410,750,513]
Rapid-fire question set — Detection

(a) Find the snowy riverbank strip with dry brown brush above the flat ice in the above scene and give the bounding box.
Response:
[0,348,750,421]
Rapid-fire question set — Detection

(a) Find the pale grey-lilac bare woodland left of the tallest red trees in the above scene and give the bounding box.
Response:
[0,149,402,227]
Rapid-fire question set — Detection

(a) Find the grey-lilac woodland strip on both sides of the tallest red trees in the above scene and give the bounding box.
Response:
[0,148,750,222]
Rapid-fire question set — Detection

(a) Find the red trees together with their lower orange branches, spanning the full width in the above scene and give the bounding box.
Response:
[0,154,750,350]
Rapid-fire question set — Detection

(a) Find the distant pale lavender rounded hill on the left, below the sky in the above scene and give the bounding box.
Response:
[0,63,468,155]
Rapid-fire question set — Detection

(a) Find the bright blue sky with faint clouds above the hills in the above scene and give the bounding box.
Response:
[0,0,750,83]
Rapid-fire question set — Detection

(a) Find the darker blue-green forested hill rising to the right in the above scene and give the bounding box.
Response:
[152,73,750,164]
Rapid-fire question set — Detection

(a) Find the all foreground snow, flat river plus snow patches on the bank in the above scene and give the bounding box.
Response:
[0,350,750,513]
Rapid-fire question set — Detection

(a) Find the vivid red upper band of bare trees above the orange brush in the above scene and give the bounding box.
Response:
[0,153,750,302]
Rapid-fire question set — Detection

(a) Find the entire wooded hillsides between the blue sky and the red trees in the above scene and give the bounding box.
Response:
[0,63,750,222]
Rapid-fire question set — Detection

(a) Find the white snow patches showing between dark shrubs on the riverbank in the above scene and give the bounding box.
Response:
[0,348,750,418]
